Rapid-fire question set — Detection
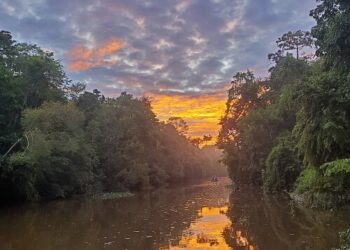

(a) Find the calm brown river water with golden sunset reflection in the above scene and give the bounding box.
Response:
[0,179,350,250]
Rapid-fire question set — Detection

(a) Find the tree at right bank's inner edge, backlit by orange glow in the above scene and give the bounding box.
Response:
[217,71,268,182]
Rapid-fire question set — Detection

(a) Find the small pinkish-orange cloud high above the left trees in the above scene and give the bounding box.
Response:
[66,38,124,72]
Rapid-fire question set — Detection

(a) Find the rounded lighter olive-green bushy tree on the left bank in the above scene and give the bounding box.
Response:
[9,103,95,200]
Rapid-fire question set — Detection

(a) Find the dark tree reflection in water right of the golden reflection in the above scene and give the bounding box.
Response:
[224,187,349,250]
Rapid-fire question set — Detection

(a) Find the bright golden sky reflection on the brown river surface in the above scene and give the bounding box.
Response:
[164,206,254,250]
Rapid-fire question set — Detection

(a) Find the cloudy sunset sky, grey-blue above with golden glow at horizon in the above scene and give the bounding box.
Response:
[0,0,316,141]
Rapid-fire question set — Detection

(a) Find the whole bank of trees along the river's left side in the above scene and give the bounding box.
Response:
[0,31,224,201]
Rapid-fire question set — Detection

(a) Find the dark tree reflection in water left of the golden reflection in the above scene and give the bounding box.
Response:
[0,181,232,250]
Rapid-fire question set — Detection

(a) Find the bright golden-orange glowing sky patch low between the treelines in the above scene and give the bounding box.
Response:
[149,90,227,143]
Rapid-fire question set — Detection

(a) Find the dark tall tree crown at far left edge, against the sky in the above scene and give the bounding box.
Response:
[0,31,68,155]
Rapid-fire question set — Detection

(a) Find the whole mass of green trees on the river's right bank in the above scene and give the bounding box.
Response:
[218,0,350,206]
